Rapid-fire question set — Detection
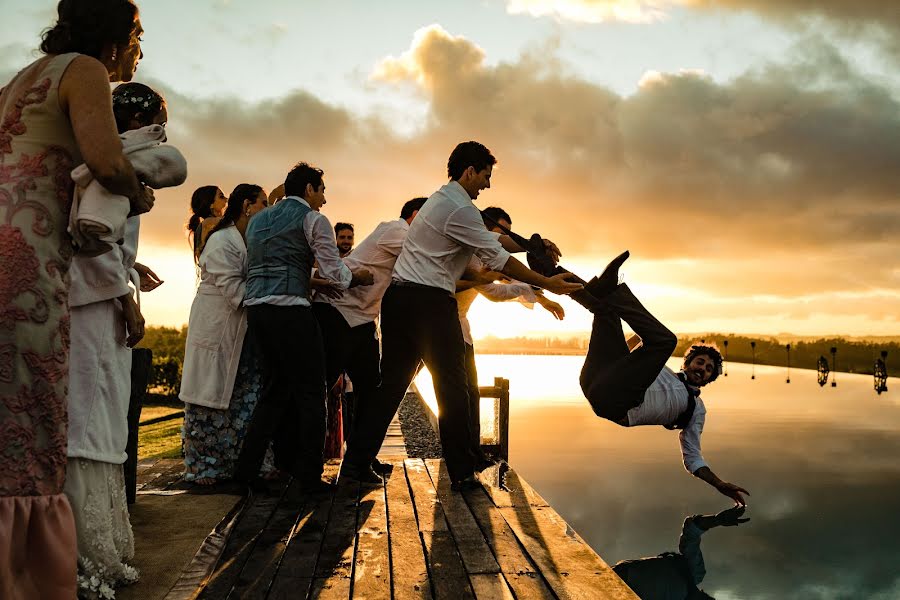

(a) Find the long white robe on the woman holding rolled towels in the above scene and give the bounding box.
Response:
[67,217,140,464]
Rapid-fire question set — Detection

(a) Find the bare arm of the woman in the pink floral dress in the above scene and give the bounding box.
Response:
[59,56,154,214]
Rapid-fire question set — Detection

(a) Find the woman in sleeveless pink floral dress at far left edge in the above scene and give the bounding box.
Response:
[0,0,153,599]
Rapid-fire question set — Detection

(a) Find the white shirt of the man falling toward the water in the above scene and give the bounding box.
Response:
[628,367,707,473]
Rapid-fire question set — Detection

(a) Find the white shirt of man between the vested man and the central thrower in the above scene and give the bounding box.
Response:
[314,219,409,327]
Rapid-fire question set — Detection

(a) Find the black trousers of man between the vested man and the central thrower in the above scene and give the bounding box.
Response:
[312,302,381,440]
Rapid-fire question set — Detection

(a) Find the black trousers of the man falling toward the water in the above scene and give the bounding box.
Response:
[581,284,678,425]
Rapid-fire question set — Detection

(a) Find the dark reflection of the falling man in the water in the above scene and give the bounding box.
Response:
[613,507,750,600]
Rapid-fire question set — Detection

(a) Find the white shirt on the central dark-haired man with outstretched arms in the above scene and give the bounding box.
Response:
[393,181,510,294]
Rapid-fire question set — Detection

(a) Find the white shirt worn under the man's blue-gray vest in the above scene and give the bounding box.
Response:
[244,196,353,306]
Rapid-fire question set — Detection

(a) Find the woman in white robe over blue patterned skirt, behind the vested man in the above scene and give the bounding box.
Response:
[179,183,268,485]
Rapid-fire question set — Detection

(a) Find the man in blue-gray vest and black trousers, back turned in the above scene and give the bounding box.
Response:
[235,162,372,492]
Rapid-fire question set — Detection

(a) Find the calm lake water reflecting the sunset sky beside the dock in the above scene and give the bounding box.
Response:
[420,355,900,600]
